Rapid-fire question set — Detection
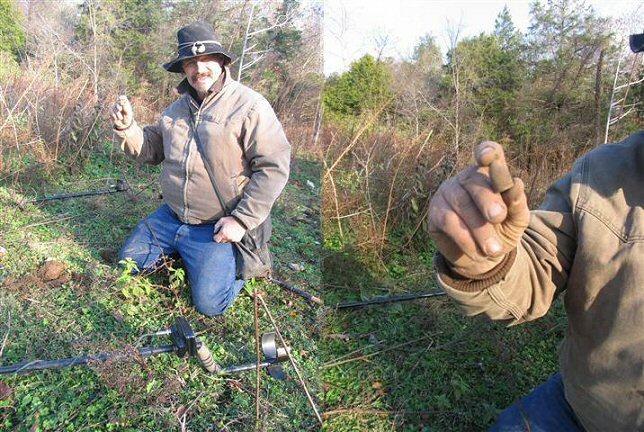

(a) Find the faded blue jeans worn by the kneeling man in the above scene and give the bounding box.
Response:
[119,204,244,316]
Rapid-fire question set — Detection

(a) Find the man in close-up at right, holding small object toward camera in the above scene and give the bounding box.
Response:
[428,35,644,432]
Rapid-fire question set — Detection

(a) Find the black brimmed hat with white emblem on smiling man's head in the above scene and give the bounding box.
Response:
[163,21,235,73]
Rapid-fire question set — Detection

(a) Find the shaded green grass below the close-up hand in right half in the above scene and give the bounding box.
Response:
[319,229,566,432]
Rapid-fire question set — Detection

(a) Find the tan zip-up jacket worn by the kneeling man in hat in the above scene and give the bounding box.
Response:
[115,70,291,230]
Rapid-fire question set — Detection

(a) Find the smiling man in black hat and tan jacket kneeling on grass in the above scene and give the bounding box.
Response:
[112,22,290,316]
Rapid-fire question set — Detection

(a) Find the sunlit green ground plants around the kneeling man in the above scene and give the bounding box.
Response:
[0,147,321,431]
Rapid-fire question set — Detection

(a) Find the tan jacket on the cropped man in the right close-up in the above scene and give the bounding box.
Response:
[436,131,644,432]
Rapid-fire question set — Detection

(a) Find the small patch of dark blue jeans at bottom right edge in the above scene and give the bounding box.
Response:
[490,373,584,432]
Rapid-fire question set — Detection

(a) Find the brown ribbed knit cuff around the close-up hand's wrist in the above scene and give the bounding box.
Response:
[434,248,517,292]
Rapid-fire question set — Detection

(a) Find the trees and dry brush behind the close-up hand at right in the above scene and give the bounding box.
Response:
[323,0,643,260]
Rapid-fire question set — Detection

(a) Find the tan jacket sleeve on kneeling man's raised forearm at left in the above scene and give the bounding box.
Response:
[114,120,165,165]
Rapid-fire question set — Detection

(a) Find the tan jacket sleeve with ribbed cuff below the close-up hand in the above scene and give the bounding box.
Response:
[435,159,583,325]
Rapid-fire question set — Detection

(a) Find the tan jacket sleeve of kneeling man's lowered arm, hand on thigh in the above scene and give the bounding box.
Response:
[231,98,291,229]
